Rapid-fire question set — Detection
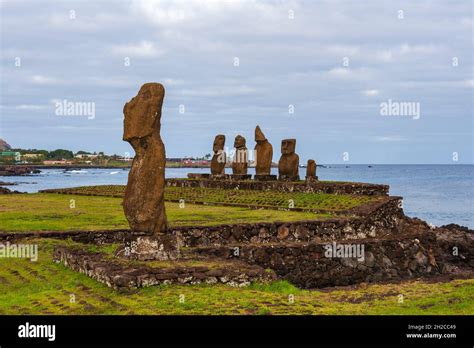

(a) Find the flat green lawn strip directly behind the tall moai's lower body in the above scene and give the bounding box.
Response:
[0,193,331,232]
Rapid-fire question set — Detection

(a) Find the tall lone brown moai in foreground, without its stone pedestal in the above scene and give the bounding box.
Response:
[123,83,167,235]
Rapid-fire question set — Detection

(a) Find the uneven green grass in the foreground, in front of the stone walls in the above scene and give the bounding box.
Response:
[0,239,474,315]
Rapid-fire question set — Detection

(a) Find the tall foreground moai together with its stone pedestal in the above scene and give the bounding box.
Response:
[116,83,180,260]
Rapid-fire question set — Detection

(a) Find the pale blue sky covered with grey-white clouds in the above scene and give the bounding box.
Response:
[0,0,474,163]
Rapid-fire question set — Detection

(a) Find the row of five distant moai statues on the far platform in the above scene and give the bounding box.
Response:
[211,126,318,181]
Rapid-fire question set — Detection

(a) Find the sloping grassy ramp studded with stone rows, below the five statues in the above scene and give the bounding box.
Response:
[41,185,383,212]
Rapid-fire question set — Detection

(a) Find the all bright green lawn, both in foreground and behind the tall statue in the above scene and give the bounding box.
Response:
[0,194,474,315]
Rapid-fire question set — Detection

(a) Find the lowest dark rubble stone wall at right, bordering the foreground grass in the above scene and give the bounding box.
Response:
[191,233,444,288]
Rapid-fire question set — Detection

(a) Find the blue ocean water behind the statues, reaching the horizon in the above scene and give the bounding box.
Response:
[0,165,474,228]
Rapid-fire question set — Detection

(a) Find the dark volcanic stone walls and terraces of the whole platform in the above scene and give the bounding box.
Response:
[39,179,474,289]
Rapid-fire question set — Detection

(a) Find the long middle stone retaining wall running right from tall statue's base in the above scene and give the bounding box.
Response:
[170,197,405,247]
